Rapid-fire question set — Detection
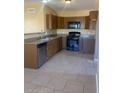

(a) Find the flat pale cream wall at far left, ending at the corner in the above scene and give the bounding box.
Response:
[24,2,44,33]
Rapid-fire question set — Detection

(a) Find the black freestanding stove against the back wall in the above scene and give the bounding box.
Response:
[67,32,80,51]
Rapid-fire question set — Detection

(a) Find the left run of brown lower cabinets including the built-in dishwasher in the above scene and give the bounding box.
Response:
[24,37,62,69]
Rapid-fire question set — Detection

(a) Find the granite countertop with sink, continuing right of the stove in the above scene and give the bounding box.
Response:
[24,33,95,45]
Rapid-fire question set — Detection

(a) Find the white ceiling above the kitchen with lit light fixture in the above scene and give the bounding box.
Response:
[25,0,98,11]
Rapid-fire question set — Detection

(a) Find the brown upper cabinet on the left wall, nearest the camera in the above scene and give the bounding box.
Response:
[46,14,57,29]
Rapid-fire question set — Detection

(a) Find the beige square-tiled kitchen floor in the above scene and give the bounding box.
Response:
[24,50,96,93]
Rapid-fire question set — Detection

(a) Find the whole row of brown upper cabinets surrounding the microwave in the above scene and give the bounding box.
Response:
[46,11,98,29]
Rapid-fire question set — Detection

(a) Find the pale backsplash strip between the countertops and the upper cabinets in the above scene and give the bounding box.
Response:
[24,29,96,39]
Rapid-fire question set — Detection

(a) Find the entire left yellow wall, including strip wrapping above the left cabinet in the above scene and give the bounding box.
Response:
[24,2,57,34]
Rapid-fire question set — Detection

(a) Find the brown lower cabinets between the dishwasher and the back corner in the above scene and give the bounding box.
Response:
[47,37,62,59]
